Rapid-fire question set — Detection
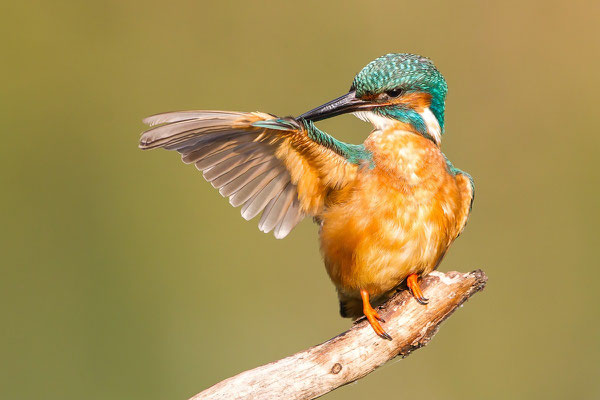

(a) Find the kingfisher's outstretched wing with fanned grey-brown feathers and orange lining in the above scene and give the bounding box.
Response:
[140,111,368,239]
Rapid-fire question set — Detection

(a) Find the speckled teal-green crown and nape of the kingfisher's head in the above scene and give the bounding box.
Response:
[351,53,448,131]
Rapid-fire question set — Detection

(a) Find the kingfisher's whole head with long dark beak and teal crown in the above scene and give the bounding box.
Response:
[299,53,448,145]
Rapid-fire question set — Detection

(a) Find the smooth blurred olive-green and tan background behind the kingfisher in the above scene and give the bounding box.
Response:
[0,0,600,400]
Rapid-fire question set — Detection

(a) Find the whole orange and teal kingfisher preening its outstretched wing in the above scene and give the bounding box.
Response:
[139,53,474,340]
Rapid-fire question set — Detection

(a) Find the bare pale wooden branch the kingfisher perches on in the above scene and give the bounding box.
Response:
[190,270,487,400]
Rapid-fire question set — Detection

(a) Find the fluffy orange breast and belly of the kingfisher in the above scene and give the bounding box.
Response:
[320,131,464,296]
